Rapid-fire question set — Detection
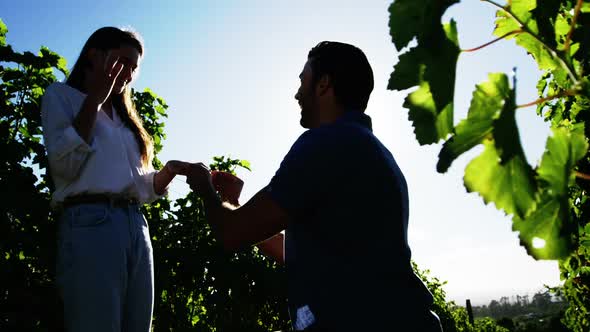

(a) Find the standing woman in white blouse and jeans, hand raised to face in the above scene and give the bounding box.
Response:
[42,27,186,332]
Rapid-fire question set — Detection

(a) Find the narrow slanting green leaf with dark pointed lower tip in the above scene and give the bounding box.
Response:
[436,73,510,173]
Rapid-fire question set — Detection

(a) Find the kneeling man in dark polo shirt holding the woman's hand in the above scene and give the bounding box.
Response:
[187,42,441,331]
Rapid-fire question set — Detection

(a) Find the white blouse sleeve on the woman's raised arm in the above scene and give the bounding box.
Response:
[41,85,93,180]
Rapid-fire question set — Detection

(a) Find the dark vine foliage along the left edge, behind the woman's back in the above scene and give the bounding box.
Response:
[0,17,67,331]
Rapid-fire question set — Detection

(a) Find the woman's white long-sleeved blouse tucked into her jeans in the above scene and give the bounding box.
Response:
[41,82,166,207]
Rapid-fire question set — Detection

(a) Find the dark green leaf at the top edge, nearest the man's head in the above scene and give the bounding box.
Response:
[389,0,459,51]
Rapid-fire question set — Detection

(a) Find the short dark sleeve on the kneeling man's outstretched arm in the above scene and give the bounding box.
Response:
[267,129,329,217]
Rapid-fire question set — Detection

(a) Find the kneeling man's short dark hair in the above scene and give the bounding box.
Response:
[307,41,374,111]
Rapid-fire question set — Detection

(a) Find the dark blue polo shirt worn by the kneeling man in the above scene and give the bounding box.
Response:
[268,111,432,330]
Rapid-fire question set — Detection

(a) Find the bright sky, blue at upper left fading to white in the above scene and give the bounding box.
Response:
[0,0,560,305]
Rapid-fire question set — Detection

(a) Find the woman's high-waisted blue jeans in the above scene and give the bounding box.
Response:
[56,203,154,332]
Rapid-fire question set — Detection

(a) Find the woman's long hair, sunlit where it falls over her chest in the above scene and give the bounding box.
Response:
[66,27,154,167]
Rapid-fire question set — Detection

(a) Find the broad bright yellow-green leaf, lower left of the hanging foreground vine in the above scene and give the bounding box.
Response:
[463,140,536,216]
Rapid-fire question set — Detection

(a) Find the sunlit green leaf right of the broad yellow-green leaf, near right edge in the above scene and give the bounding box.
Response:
[537,125,588,198]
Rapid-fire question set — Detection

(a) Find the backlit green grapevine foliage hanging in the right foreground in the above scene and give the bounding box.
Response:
[388,0,590,331]
